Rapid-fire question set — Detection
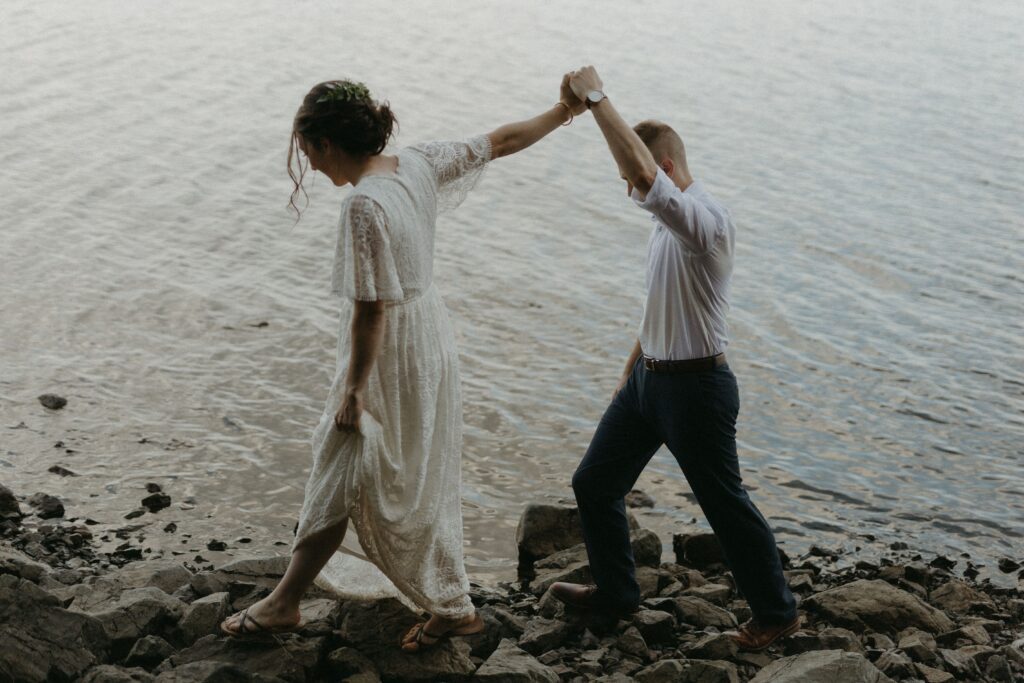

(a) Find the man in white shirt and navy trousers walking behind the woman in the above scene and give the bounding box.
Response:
[552,67,800,650]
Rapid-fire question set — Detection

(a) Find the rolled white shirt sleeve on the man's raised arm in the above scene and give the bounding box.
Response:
[631,169,725,254]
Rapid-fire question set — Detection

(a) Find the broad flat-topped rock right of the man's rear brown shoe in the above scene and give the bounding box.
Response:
[803,579,954,633]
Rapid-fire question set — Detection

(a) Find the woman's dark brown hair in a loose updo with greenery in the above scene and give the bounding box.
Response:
[288,80,398,220]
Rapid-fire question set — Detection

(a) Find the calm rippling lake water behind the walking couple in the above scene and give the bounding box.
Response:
[0,0,1024,580]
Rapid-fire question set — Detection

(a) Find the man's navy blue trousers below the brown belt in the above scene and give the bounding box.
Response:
[572,360,797,625]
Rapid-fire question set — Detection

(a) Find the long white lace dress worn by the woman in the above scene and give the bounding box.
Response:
[292,136,490,617]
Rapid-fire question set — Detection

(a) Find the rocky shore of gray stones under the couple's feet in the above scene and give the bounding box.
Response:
[0,485,1024,683]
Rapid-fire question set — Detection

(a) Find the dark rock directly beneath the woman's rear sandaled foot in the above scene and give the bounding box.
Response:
[340,599,476,681]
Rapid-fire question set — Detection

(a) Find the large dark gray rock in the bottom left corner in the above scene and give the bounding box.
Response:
[0,574,109,683]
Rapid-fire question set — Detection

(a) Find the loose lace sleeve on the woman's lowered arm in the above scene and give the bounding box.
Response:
[332,195,404,301]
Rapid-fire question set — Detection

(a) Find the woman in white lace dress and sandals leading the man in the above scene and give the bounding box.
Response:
[221,78,585,651]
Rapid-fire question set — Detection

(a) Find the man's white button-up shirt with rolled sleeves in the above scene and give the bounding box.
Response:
[632,169,736,360]
